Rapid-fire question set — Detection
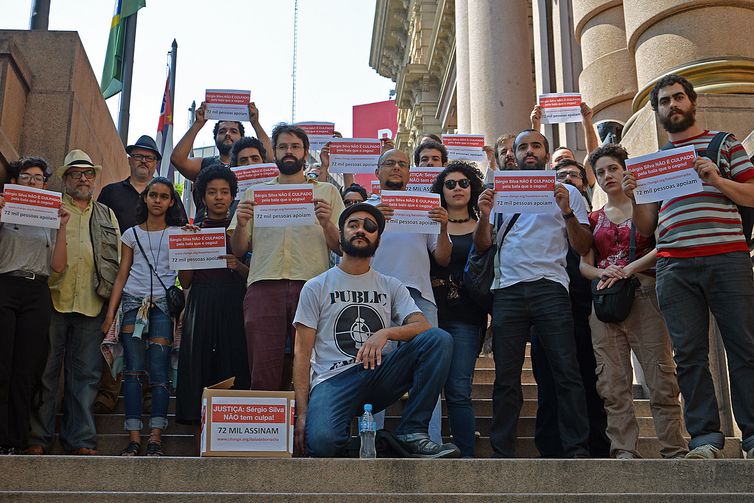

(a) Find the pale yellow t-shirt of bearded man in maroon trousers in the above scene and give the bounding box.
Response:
[228,178,344,285]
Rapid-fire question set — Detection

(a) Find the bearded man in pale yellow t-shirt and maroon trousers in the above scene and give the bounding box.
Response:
[228,124,343,390]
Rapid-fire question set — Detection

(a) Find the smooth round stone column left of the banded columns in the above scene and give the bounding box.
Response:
[459,0,534,145]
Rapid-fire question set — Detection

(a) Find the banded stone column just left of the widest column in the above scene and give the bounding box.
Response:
[573,0,637,124]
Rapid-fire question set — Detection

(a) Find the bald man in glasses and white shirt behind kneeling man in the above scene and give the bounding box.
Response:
[368,149,453,444]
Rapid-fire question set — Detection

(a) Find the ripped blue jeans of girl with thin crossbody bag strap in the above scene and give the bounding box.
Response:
[120,307,173,431]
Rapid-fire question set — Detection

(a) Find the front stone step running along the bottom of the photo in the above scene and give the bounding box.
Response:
[0,456,754,501]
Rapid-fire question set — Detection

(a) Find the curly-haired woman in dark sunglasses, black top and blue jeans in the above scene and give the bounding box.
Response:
[430,161,487,457]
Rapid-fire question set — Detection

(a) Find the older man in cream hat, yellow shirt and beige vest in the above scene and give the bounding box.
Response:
[27,150,120,454]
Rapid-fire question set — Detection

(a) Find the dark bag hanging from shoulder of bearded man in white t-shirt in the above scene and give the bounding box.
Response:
[463,213,521,313]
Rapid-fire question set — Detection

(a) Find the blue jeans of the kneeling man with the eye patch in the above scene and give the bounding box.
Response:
[306,328,453,457]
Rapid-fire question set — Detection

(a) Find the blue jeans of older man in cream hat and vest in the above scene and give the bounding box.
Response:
[29,309,105,451]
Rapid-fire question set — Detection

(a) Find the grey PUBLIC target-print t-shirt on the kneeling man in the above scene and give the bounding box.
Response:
[293,267,421,389]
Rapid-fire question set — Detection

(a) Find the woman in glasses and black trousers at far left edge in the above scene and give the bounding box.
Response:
[0,157,70,454]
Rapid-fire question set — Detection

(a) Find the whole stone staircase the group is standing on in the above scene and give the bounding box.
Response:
[0,346,754,503]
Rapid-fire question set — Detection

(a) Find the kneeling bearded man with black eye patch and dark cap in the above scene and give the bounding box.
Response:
[293,203,460,458]
